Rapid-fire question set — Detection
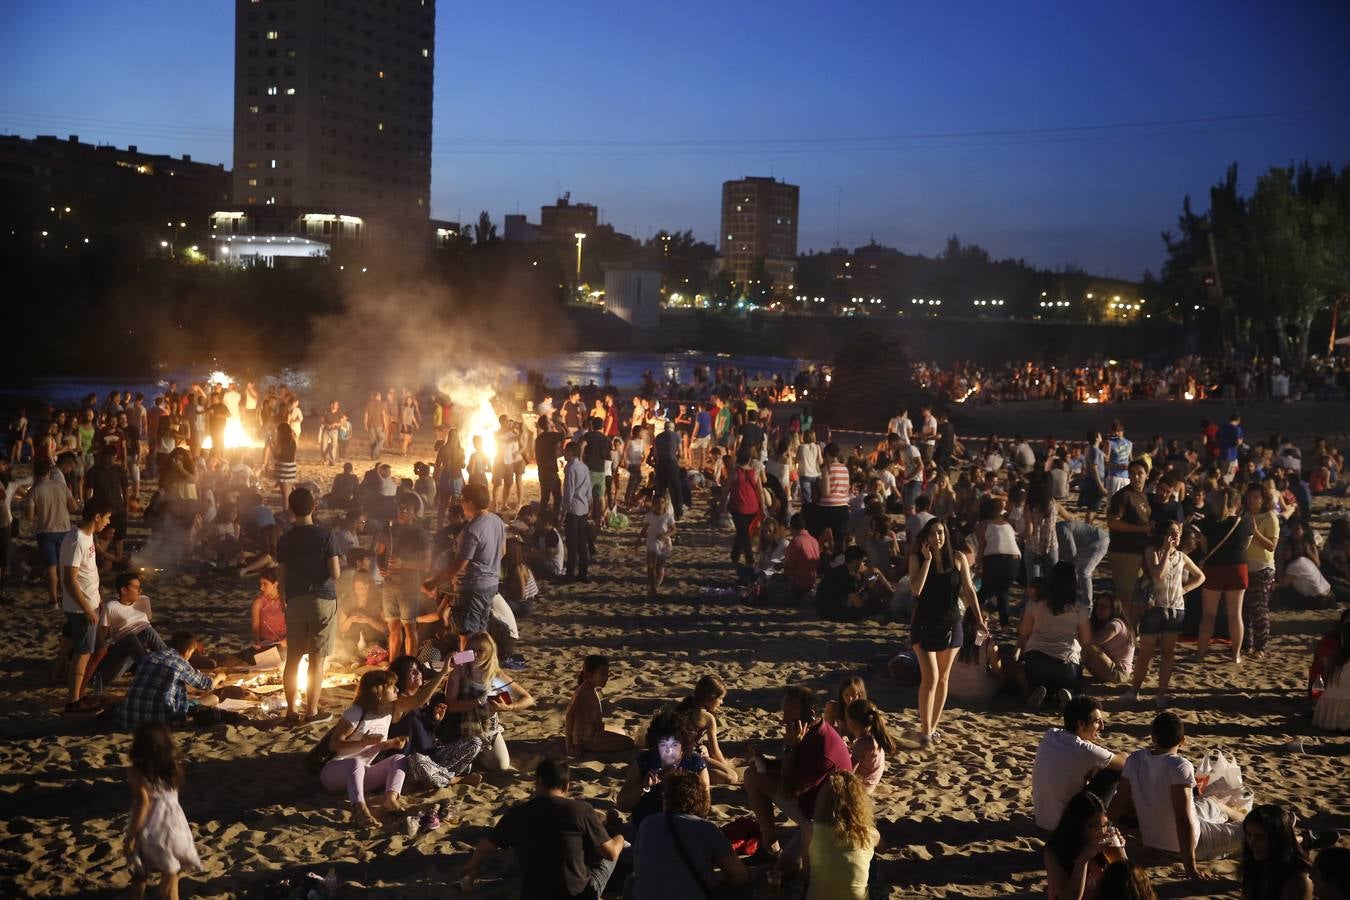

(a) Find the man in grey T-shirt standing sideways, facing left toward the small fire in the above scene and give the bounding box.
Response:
[423,484,506,650]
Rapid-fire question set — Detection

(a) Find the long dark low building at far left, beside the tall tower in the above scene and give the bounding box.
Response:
[0,135,230,242]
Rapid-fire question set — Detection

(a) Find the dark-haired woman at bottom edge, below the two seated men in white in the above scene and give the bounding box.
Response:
[1044,791,1125,900]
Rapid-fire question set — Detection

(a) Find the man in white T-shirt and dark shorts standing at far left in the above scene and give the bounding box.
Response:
[57,499,112,712]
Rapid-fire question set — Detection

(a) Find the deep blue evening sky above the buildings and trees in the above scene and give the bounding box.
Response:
[0,0,1350,278]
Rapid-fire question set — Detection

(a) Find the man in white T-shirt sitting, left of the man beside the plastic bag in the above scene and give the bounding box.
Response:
[1031,696,1125,831]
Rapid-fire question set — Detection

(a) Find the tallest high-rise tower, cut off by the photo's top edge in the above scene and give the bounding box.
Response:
[234,0,436,233]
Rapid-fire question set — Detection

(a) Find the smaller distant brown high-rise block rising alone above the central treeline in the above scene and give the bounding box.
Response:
[718,177,799,291]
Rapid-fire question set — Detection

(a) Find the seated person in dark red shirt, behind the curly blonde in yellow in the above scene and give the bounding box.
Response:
[744,685,853,854]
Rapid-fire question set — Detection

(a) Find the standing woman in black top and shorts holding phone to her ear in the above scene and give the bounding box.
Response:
[909,518,988,748]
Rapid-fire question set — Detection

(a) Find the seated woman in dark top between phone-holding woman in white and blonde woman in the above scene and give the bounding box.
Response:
[389,656,483,789]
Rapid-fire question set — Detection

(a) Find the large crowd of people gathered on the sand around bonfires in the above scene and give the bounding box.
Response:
[0,360,1350,900]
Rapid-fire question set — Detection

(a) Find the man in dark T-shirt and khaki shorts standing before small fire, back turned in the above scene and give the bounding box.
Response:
[277,487,342,723]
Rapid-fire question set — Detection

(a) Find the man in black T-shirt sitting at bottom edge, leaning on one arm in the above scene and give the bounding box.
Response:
[459,758,625,900]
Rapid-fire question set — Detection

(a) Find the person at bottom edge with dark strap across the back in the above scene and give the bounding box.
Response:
[632,770,751,900]
